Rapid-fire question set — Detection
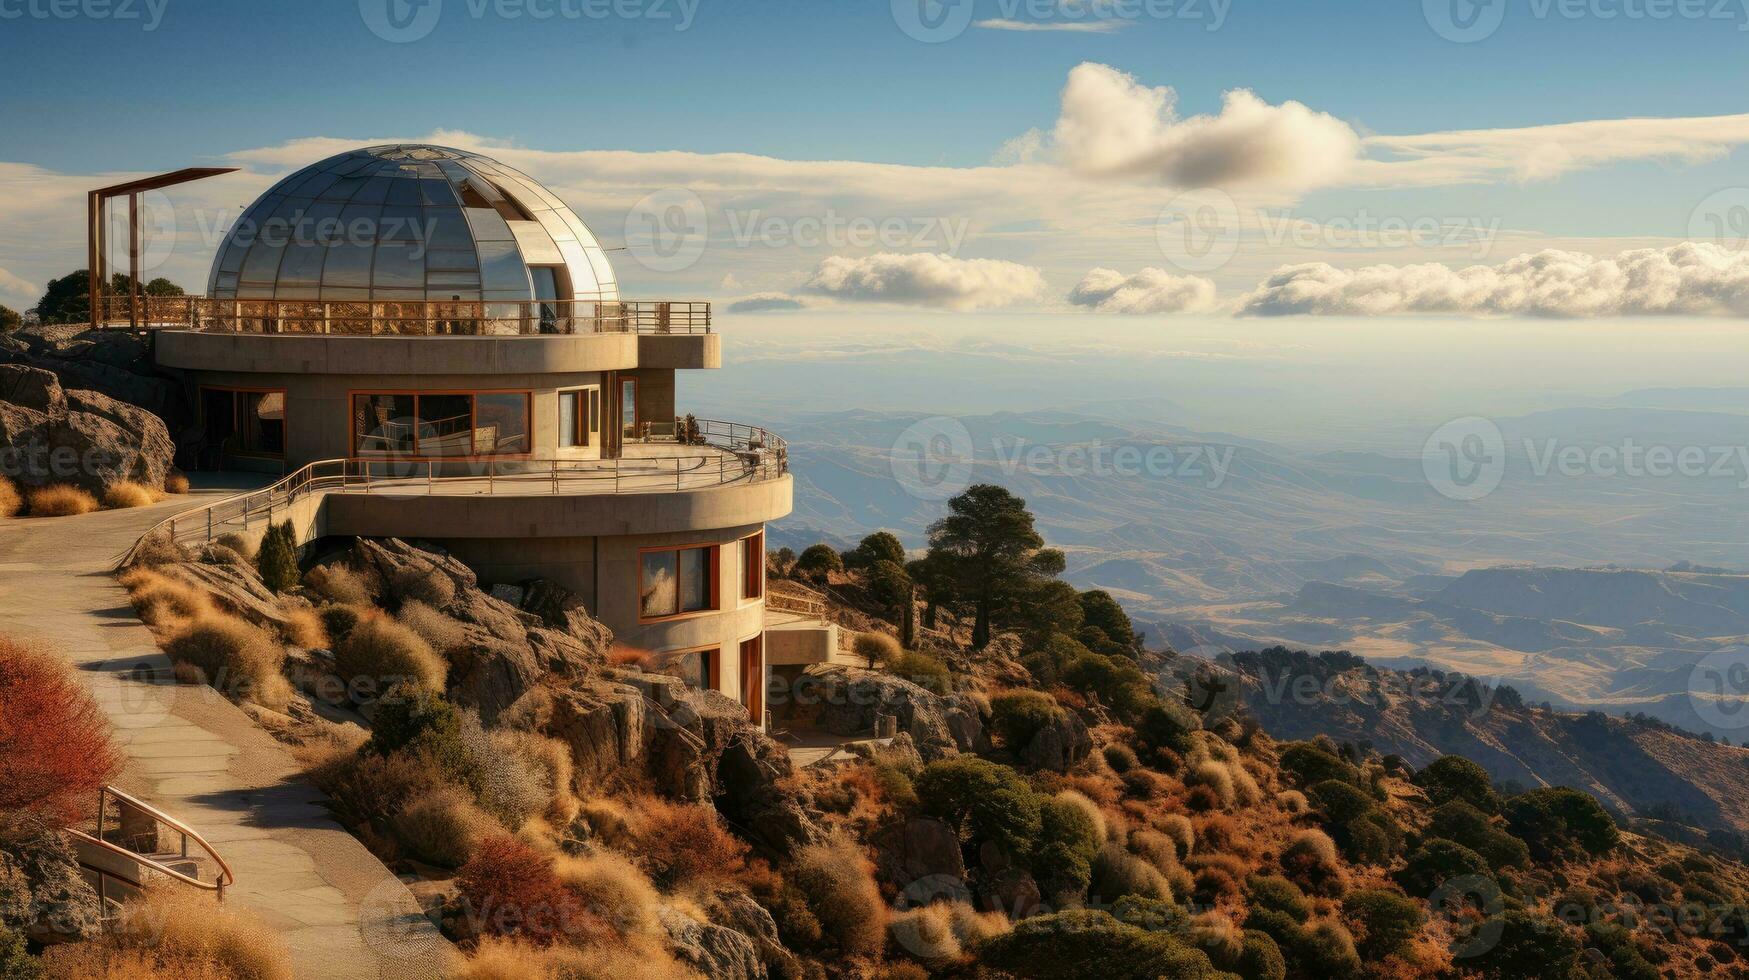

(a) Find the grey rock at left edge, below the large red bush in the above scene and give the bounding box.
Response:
[0,831,101,945]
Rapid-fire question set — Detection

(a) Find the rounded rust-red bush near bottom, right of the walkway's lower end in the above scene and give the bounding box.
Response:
[456,833,584,947]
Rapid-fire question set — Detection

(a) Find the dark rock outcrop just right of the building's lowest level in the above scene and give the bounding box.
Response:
[796,667,990,761]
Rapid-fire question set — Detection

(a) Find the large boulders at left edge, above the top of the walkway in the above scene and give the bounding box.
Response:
[0,364,177,492]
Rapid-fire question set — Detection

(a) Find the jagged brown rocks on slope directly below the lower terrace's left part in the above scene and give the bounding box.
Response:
[350,537,612,725]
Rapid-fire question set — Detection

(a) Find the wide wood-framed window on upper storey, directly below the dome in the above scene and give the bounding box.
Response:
[352,392,533,459]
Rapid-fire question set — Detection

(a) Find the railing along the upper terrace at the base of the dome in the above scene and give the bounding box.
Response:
[93,296,710,336]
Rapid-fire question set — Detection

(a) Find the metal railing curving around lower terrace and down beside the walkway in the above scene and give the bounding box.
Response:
[126,418,789,567]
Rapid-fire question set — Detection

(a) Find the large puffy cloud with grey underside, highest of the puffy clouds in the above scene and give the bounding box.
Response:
[1055,61,1361,187]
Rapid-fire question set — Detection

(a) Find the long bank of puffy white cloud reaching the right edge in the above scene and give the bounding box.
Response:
[1240,242,1749,317]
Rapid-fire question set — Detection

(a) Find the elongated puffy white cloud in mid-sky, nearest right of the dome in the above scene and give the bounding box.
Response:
[805,252,1044,310]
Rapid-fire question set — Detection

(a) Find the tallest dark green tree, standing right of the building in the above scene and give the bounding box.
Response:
[929,483,1063,649]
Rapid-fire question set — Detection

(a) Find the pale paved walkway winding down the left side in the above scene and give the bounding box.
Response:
[0,483,448,978]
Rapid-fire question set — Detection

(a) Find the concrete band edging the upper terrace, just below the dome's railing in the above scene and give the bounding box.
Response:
[156,331,650,376]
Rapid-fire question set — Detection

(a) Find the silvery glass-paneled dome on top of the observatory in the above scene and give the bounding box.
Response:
[206,145,619,303]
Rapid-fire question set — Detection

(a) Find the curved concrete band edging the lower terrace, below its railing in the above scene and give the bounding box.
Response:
[324,476,794,539]
